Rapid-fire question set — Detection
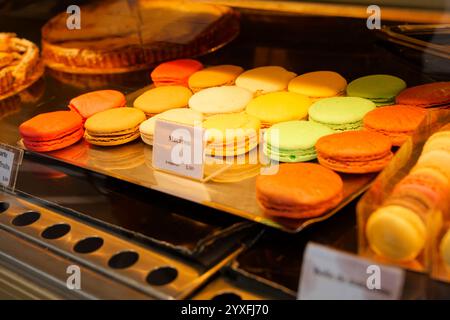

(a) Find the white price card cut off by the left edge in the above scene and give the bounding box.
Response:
[0,143,23,191]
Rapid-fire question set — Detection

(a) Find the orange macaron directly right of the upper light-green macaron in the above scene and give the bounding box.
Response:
[363,105,426,146]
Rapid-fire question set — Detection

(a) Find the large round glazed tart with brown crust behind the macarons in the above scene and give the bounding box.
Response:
[42,0,239,74]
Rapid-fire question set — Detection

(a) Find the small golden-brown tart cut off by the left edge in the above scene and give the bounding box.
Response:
[0,33,44,99]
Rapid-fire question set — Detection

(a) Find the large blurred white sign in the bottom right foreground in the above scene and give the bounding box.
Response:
[297,243,405,300]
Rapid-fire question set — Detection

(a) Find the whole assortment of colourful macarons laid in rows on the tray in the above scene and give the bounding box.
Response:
[15,59,450,218]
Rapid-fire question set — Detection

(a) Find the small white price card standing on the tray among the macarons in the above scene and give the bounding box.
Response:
[152,119,205,180]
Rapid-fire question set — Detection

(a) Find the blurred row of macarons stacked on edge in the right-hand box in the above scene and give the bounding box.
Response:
[365,125,450,268]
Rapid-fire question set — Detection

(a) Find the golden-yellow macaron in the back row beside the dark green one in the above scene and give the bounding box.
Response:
[288,71,347,101]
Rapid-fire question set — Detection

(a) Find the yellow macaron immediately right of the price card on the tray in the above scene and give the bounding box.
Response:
[203,113,261,157]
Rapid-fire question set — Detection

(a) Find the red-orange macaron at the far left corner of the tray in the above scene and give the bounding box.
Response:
[19,111,84,152]
